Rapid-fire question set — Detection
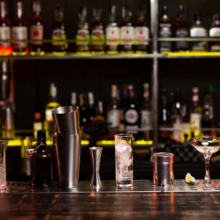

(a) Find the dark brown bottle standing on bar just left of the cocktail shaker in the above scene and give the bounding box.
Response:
[32,130,52,188]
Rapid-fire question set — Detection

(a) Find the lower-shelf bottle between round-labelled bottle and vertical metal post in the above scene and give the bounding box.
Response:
[141,83,153,129]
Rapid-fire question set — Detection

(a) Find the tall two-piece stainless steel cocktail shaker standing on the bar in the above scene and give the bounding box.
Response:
[52,106,81,188]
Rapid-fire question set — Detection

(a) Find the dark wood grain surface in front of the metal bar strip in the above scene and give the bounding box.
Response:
[0,192,220,220]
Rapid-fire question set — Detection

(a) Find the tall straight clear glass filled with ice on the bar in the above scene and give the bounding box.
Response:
[115,134,133,187]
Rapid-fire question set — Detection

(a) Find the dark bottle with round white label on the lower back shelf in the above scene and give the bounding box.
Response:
[124,85,140,135]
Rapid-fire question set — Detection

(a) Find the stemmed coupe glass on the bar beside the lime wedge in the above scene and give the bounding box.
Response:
[192,136,220,189]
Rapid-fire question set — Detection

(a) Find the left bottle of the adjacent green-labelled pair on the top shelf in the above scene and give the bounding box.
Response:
[76,6,90,55]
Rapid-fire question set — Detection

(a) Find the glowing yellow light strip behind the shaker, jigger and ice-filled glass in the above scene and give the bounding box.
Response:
[8,140,153,147]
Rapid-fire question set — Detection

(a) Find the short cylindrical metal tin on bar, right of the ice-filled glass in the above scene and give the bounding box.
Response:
[153,152,174,188]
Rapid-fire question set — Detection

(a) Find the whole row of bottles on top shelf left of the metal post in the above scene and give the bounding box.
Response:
[0,1,149,55]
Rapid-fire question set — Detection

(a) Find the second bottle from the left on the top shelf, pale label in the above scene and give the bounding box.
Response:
[11,2,28,55]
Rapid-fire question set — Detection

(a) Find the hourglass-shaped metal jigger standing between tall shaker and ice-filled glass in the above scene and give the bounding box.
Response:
[89,147,102,187]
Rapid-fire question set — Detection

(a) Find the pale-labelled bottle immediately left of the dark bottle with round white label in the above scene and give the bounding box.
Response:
[107,85,120,128]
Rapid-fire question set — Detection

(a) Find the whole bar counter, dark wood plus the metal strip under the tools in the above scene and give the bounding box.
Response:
[0,180,220,220]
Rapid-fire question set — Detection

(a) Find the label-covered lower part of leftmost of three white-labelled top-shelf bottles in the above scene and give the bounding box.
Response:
[106,27,120,51]
